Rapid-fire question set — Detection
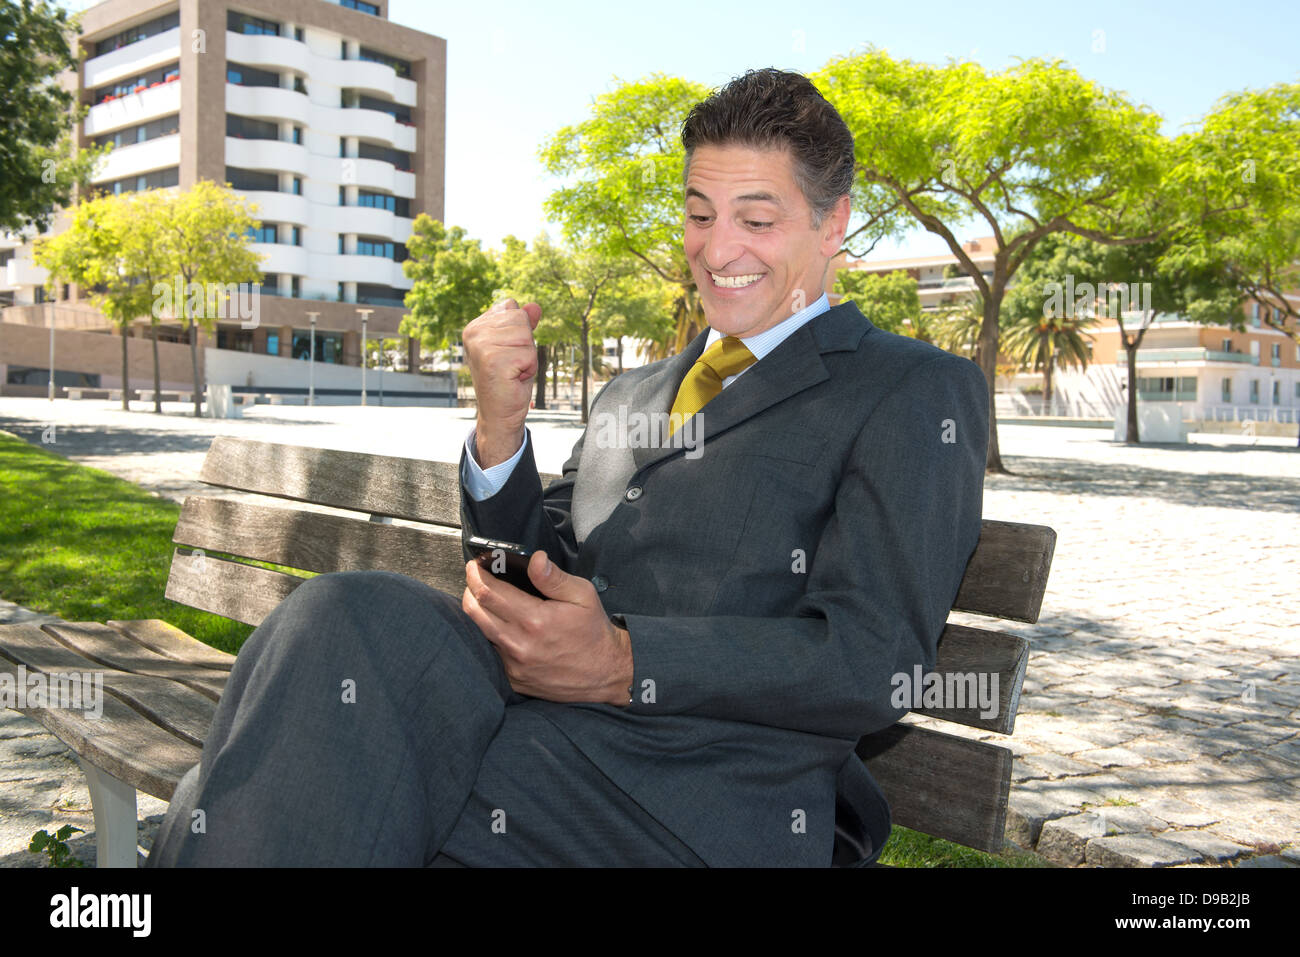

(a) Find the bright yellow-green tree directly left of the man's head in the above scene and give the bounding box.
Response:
[538,73,709,351]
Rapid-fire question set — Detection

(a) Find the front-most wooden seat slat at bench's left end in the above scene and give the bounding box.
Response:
[0,658,200,801]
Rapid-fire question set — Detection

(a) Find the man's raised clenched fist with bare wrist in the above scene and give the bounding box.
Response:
[460,299,542,468]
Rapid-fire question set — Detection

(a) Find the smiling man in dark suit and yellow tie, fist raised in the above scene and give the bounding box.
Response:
[151,69,988,866]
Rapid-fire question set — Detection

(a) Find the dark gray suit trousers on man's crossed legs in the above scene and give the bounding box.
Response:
[147,571,703,867]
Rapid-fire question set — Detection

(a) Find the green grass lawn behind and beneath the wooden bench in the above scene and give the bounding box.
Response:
[0,432,1049,867]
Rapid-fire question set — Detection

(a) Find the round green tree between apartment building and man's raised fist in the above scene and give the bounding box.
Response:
[399,213,501,366]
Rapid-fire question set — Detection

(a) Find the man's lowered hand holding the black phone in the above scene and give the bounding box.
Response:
[460,550,633,706]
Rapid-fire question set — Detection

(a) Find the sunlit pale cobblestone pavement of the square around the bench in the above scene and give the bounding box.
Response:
[0,398,1300,867]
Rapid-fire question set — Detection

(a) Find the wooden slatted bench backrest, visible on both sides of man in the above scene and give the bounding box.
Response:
[166,437,1056,850]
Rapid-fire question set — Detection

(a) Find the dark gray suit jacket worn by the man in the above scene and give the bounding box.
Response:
[462,302,988,866]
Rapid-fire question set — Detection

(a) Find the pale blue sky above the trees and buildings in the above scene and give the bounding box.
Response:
[65,0,1300,259]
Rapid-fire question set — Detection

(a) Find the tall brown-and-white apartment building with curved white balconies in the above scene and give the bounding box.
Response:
[0,0,446,400]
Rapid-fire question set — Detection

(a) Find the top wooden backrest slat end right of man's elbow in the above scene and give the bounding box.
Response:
[953,519,1056,624]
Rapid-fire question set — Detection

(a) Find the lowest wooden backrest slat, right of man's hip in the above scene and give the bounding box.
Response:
[855,723,1011,853]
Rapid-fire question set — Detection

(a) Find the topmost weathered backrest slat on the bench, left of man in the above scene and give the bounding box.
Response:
[199,436,460,525]
